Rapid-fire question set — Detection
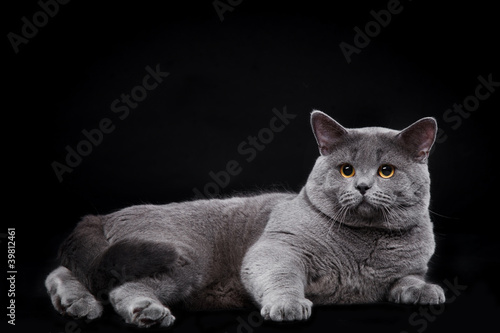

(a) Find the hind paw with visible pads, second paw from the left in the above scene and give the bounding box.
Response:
[126,299,175,327]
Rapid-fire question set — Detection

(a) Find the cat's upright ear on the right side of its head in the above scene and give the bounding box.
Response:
[396,117,437,163]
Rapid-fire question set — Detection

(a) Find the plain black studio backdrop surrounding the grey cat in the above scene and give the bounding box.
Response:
[0,0,500,333]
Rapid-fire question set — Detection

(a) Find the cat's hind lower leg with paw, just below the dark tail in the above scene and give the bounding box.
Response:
[109,279,175,327]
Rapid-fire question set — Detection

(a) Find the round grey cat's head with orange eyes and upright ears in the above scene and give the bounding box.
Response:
[306,111,437,229]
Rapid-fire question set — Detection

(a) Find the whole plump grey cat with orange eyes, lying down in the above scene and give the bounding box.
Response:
[45,110,445,327]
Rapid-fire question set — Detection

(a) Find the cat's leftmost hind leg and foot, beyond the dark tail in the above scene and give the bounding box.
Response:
[45,266,103,320]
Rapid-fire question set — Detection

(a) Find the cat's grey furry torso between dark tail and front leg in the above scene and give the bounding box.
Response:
[98,193,295,309]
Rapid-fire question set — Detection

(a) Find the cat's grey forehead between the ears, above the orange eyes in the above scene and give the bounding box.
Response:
[333,127,400,164]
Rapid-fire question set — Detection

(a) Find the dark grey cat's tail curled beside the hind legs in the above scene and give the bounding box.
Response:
[59,215,179,296]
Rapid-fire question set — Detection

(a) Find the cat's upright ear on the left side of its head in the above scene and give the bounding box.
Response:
[311,110,347,155]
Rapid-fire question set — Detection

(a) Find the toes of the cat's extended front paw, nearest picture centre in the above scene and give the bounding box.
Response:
[260,298,312,321]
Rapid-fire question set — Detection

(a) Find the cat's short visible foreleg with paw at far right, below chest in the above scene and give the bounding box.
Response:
[388,275,445,304]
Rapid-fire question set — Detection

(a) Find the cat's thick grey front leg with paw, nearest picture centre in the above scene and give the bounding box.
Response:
[241,240,312,321]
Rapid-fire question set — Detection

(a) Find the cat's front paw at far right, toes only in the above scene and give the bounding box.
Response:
[389,283,445,304]
